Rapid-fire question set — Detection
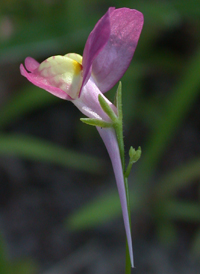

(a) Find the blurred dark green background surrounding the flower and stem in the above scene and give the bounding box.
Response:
[0,0,200,274]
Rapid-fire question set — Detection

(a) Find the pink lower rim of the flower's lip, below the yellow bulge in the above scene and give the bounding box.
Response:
[20,63,71,100]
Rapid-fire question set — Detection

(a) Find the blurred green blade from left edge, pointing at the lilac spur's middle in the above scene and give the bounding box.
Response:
[0,134,105,174]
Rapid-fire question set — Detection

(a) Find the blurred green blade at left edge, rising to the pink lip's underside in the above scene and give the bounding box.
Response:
[0,85,59,128]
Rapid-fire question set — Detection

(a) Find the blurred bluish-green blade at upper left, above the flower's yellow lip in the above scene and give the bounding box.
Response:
[0,25,90,63]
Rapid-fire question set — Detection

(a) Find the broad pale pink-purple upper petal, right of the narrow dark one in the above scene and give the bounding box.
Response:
[92,8,144,92]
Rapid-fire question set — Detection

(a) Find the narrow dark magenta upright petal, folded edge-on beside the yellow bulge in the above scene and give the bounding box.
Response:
[79,8,115,94]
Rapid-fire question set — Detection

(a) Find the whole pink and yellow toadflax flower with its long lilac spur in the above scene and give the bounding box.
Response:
[20,7,143,266]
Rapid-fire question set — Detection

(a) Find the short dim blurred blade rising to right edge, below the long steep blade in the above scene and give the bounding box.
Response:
[156,158,200,198]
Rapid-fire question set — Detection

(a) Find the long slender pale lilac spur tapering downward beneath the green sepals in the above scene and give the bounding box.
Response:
[97,127,134,267]
